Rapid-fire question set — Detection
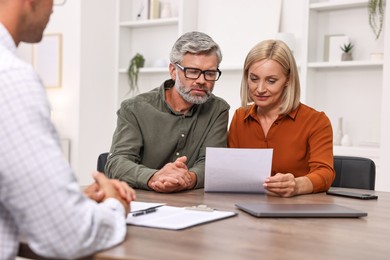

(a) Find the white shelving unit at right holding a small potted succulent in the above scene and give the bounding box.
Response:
[300,0,388,164]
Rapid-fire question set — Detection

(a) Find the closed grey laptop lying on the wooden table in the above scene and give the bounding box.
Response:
[236,203,367,218]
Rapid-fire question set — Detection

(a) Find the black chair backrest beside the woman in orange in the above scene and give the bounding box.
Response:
[332,155,375,190]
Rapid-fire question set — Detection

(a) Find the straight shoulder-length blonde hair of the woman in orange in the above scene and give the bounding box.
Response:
[241,40,301,114]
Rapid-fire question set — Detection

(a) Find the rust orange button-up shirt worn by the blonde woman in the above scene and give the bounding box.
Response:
[228,104,335,193]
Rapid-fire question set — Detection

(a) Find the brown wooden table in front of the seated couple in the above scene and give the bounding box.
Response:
[94,190,390,260]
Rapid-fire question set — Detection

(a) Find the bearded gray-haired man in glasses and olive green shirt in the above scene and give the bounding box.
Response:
[105,32,230,193]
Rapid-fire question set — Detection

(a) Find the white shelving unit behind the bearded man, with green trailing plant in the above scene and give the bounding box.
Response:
[116,0,198,106]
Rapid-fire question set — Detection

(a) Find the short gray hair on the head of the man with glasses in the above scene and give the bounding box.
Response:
[169,31,222,66]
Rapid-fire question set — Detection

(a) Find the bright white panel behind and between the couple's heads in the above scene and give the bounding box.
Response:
[197,0,282,68]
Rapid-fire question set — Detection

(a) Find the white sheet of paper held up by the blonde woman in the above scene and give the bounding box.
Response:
[205,147,273,193]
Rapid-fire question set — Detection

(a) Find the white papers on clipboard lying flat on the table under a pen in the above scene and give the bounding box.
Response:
[126,201,237,230]
